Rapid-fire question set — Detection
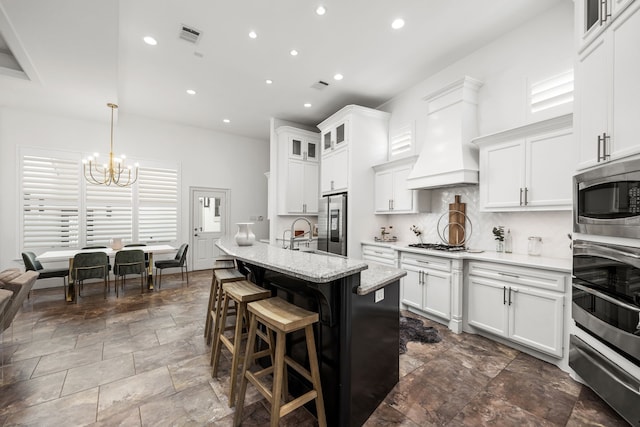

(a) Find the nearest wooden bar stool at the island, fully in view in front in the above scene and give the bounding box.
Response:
[233,297,327,427]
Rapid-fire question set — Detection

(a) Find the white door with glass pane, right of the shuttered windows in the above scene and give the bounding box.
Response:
[191,188,229,270]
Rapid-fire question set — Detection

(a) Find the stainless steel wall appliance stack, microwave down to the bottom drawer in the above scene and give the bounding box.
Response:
[569,160,640,426]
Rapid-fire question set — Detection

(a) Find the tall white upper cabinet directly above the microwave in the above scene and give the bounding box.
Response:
[575,0,640,169]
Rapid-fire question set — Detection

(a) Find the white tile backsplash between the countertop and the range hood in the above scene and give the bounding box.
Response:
[382,186,572,258]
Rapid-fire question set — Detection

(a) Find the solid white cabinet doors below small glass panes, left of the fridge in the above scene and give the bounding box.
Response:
[285,160,318,214]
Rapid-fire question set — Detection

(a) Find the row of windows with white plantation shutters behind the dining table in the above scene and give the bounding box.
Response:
[21,148,179,250]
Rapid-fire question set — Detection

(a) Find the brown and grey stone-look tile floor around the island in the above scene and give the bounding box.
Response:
[0,271,626,426]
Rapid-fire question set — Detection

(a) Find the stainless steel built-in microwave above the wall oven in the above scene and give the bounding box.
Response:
[573,159,640,238]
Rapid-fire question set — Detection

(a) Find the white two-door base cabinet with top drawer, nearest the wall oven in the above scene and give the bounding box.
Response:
[468,261,568,357]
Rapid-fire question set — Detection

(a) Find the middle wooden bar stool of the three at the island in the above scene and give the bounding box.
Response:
[211,280,272,407]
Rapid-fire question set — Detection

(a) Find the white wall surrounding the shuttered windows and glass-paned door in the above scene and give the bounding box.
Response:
[0,107,269,269]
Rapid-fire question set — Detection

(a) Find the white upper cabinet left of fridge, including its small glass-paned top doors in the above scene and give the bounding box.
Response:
[276,126,320,215]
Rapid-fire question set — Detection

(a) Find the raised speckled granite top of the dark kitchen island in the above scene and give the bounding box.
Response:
[216,236,368,283]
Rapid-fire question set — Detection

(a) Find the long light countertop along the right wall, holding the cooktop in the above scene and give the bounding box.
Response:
[362,240,572,273]
